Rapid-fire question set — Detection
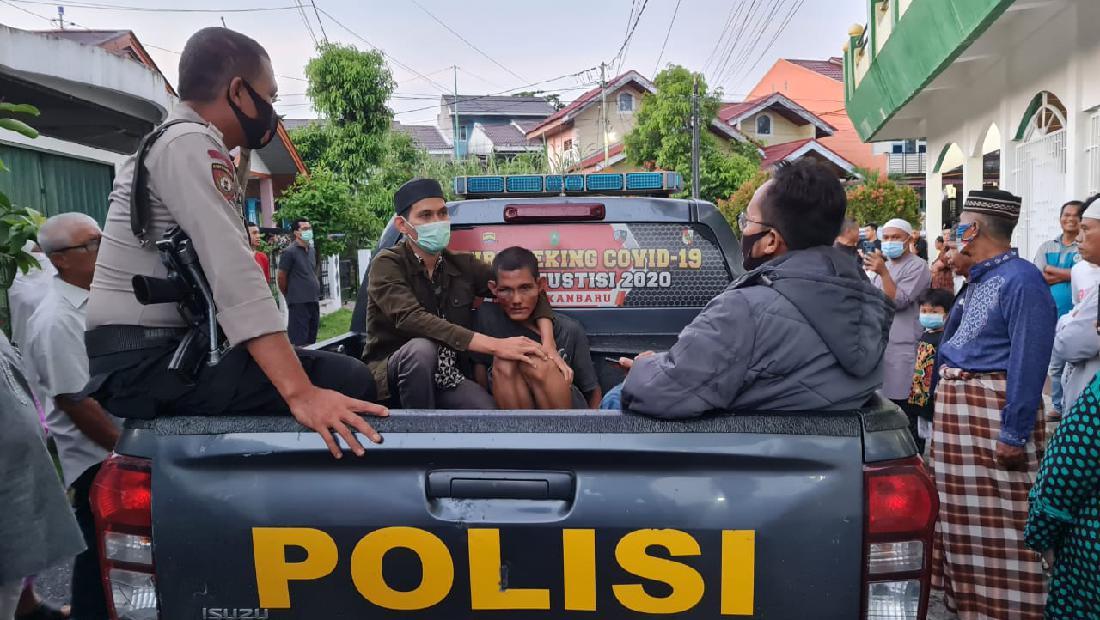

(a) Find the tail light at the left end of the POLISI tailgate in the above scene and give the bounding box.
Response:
[90,454,157,620]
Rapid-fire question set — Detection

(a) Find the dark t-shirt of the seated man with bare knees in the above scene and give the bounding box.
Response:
[473,303,600,394]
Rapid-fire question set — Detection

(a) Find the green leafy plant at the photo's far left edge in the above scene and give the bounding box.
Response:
[0,101,43,335]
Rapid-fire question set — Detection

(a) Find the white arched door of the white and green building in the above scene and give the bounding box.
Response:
[1015,130,1066,261]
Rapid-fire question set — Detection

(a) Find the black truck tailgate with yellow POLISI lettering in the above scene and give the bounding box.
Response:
[130,411,864,620]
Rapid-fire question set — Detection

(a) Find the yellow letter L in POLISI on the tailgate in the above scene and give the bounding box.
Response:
[466,529,550,610]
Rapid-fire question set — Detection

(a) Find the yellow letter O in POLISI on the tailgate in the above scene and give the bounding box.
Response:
[351,528,454,611]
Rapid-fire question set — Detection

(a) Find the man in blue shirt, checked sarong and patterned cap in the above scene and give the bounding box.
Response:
[933,190,1057,620]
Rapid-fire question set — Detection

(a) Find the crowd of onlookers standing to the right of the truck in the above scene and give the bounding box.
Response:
[836,192,1100,619]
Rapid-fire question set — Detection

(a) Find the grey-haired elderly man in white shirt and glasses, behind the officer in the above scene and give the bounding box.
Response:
[23,213,119,618]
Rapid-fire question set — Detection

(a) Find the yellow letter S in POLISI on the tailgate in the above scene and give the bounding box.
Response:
[612,530,704,613]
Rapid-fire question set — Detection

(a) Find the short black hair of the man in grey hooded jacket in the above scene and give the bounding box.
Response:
[760,159,848,250]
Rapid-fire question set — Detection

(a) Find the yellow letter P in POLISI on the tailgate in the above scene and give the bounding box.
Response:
[252,528,337,609]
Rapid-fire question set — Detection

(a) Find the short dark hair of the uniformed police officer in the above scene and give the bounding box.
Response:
[179,26,271,101]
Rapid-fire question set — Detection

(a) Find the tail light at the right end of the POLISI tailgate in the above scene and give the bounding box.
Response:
[864,456,939,620]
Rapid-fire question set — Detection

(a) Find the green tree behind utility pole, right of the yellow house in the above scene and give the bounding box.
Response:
[625,65,760,201]
